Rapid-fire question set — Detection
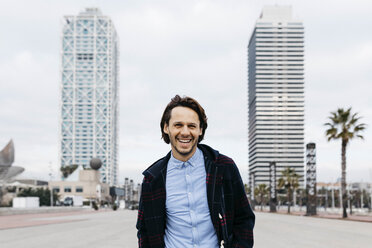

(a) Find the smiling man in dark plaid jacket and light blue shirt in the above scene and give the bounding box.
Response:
[137,95,255,248]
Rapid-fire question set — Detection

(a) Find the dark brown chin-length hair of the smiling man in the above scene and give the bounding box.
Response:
[160,95,208,144]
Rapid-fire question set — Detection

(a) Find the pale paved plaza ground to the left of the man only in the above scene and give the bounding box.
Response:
[0,210,137,248]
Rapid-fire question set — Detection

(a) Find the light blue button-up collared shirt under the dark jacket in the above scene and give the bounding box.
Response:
[164,148,219,248]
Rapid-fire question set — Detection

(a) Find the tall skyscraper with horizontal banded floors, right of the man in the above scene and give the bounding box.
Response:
[248,6,304,185]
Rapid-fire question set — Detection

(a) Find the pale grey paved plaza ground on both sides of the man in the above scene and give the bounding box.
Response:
[0,210,372,248]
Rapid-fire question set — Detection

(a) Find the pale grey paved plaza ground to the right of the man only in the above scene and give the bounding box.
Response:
[255,212,372,248]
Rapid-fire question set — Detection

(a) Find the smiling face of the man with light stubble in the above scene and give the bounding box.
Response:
[163,107,202,161]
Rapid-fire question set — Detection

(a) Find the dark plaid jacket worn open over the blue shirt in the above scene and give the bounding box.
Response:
[137,144,255,248]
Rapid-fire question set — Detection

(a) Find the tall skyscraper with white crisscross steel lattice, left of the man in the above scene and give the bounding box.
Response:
[60,8,119,185]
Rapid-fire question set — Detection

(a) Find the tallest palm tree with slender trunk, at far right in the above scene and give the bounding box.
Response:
[324,108,366,218]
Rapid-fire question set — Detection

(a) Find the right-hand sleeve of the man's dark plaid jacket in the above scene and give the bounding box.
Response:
[232,164,255,248]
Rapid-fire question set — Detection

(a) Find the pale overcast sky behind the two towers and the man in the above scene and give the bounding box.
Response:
[0,0,372,182]
